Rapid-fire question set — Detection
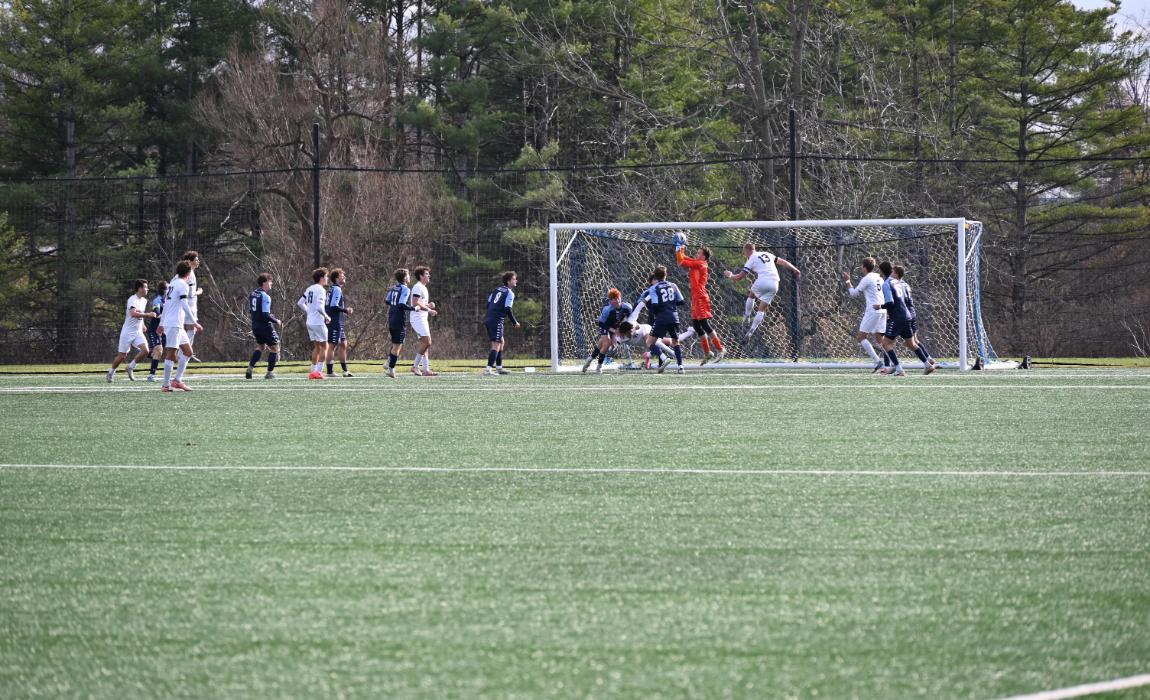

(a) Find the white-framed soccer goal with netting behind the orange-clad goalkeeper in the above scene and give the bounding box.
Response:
[550,218,1012,371]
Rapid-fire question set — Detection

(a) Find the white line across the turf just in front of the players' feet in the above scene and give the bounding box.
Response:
[0,379,1150,394]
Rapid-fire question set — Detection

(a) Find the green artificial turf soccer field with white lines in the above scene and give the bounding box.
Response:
[0,369,1150,699]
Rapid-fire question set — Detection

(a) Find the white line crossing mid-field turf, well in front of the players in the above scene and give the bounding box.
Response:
[0,463,1150,478]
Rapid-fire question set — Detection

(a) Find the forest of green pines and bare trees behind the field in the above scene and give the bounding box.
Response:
[0,0,1150,362]
